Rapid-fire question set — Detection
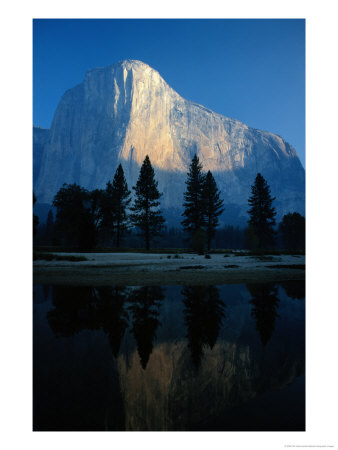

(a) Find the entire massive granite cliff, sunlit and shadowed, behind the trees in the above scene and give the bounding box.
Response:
[34,60,305,221]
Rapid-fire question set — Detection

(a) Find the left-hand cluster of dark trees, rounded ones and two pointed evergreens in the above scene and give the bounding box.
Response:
[48,156,164,250]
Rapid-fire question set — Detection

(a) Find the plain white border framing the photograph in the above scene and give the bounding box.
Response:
[0,0,338,450]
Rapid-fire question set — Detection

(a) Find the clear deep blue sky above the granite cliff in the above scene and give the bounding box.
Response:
[33,19,305,165]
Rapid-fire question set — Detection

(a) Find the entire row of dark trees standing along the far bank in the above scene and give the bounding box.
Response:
[33,155,305,253]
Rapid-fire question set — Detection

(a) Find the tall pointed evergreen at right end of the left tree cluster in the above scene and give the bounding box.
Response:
[131,155,165,250]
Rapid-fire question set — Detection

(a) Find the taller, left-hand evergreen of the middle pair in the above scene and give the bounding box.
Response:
[181,155,205,246]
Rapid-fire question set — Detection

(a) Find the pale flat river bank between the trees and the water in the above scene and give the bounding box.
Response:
[33,252,305,286]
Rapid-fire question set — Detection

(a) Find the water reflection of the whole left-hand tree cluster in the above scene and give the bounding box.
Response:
[47,286,164,369]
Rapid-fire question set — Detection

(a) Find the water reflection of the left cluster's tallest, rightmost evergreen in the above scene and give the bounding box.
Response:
[128,286,164,369]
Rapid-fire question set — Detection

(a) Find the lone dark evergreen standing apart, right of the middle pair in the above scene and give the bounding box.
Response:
[248,173,276,248]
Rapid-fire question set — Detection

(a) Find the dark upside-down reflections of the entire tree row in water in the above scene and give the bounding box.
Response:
[43,282,305,369]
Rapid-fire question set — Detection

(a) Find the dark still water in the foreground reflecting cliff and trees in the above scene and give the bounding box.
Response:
[33,282,305,431]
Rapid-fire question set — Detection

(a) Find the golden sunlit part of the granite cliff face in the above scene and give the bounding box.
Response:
[113,61,296,172]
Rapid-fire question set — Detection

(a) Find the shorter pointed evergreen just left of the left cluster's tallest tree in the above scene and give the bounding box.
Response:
[101,164,131,247]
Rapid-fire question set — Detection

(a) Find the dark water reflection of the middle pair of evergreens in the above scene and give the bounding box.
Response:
[182,286,225,369]
